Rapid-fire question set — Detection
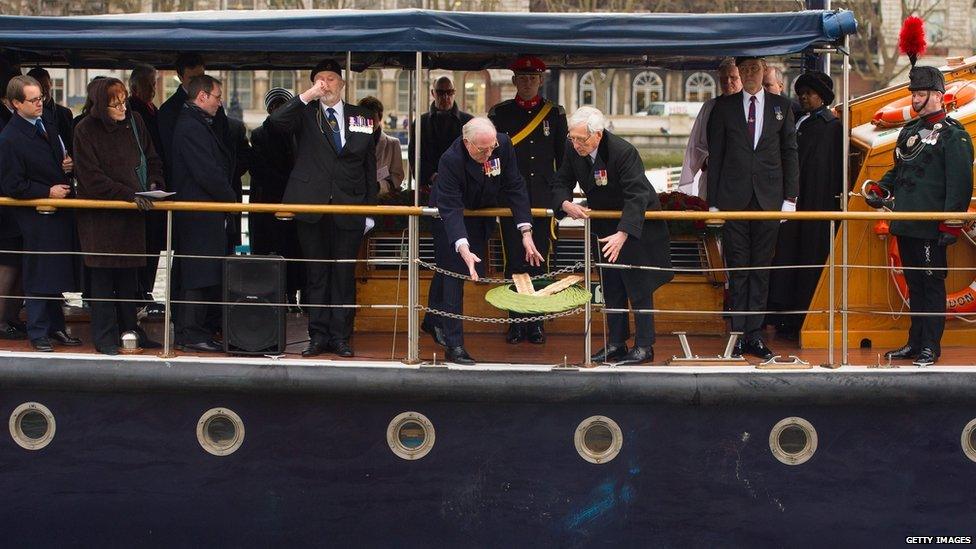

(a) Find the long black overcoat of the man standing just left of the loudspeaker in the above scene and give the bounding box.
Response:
[172,106,237,290]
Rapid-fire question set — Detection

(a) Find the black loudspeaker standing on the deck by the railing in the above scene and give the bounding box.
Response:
[223,256,288,355]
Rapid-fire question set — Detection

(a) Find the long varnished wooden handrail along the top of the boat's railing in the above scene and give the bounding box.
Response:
[0,197,976,221]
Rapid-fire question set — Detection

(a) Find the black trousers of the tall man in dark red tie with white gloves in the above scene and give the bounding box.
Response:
[722,196,779,341]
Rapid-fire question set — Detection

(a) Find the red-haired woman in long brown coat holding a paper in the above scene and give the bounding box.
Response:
[74,78,163,355]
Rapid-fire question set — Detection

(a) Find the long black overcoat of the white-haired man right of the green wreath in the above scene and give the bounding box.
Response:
[550,131,674,292]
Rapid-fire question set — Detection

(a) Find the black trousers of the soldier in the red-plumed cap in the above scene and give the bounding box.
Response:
[897,236,948,355]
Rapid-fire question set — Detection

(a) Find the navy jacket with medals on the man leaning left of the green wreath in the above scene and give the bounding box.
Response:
[430,133,532,274]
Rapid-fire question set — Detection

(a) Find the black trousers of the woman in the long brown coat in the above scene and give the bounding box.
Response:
[90,267,142,348]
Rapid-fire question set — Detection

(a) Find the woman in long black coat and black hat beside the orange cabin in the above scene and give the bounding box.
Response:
[766,71,844,340]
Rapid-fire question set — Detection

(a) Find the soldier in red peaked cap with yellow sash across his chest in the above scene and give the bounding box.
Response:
[488,55,569,344]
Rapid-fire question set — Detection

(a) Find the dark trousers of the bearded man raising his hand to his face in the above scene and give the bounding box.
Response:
[297,215,365,344]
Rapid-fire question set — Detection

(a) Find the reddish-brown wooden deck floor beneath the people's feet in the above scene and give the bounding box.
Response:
[0,308,976,367]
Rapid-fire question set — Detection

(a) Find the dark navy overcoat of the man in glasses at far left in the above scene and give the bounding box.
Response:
[0,110,75,295]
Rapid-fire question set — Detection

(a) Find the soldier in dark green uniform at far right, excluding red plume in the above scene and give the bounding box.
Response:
[865,67,973,366]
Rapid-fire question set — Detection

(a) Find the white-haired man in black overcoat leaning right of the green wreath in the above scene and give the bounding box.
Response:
[552,107,674,365]
